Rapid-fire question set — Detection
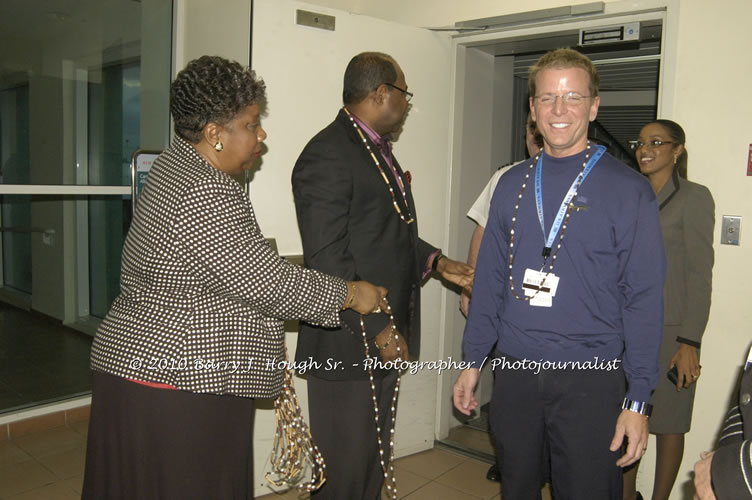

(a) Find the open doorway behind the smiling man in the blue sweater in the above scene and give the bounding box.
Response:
[438,11,665,462]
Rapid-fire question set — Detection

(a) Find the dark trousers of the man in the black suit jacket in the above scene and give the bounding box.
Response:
[308,371,397,500]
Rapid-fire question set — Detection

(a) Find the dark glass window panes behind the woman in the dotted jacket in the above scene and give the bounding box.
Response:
[0,0,173,413]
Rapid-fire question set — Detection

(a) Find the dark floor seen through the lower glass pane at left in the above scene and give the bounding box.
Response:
[0,302,92,413]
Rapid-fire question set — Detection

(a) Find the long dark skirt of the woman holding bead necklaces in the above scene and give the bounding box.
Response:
[81,371,254,500]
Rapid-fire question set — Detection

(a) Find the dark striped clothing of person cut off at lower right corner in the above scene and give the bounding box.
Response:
[710,350,752,500]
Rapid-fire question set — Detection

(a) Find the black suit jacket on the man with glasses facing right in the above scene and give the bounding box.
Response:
[292,110,437,380]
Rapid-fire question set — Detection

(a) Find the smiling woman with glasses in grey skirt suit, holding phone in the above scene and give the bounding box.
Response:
[624,120,715,500]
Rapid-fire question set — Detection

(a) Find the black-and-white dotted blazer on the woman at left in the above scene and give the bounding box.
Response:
[91,138,347,398]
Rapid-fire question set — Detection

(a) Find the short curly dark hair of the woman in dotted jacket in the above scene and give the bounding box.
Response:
[170,56,266,144]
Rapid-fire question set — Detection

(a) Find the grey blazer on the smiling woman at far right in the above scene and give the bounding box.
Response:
[658,169,715,347]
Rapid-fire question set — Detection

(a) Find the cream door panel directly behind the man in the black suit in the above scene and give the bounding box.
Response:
[251,0,450,496]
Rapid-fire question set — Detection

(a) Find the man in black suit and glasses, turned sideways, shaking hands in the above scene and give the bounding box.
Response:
[292,52,472,500]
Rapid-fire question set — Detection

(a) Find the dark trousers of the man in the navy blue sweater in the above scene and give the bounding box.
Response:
[489,354,625,500]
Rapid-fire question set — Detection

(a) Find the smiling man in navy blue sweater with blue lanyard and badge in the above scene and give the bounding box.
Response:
[454,49,666,499]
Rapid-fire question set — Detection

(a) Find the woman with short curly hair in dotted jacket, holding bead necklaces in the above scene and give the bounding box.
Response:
[82,56,388,499]
